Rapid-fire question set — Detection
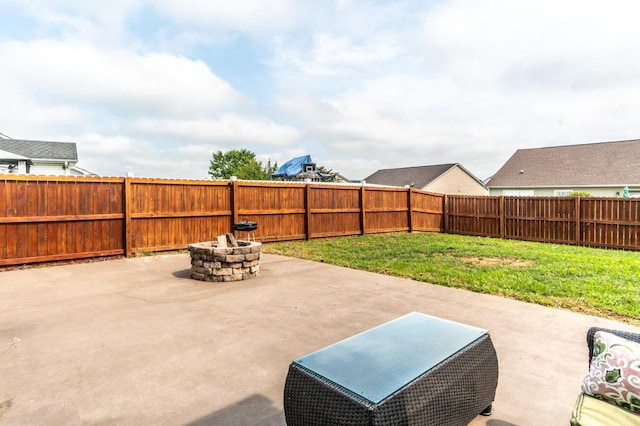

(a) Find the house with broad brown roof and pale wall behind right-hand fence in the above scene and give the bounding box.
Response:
[487,139,640,197]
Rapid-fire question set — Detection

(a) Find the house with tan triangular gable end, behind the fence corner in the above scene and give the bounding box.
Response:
[364,163,489,195]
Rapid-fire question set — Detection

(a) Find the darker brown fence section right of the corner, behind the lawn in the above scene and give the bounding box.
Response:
[445,196,640,250]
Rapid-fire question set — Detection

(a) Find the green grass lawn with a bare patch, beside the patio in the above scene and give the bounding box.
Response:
[263,233,640,325]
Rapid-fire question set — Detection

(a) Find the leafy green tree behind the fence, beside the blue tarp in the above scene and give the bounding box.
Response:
[209,149,278,180]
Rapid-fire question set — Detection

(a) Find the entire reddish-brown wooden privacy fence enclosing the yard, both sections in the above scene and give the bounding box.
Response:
[0,175,640,266]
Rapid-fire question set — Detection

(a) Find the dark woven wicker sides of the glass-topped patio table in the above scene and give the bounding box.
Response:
[284,312,498,426]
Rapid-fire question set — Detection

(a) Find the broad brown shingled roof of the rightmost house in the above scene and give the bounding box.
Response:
[487,139,640,188]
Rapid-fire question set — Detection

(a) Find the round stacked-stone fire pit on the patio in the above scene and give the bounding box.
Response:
[189,240,262,282]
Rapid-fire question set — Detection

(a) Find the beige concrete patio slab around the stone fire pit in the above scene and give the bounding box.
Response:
[0,254,640,426]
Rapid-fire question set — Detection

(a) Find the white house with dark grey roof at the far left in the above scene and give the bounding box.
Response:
[0,139,95,176]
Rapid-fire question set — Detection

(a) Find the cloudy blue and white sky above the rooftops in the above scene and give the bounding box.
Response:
[0,0,640,180]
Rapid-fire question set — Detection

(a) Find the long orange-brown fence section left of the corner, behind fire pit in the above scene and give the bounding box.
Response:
[0,175,445,266]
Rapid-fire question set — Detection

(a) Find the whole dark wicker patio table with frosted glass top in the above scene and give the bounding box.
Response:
[284,312,498,426]
